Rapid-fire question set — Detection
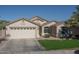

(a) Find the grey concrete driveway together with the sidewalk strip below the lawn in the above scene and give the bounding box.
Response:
[0,39,75,54]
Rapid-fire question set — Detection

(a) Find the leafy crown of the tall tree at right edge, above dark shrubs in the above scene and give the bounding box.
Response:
[65,6,79,27]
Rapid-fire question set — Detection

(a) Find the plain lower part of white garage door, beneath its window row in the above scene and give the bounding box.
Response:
[10,30,36,39]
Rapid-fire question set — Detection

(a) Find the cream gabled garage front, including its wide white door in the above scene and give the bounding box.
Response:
[6,20,39,39]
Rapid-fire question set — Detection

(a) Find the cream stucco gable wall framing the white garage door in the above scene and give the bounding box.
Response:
[6,20,40,38]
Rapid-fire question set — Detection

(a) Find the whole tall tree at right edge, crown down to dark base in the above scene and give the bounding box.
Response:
[65,6,79,39]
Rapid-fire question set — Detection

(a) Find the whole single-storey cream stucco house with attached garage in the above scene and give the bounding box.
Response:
[6,16,64,39]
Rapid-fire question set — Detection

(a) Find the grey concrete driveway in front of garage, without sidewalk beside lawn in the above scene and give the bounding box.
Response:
[0,39,42,54]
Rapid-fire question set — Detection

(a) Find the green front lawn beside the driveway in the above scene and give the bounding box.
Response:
[39,40,79,50]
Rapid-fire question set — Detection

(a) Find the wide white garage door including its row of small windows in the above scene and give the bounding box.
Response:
[9,27,36,39]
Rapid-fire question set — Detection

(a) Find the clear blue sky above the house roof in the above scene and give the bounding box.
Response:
[0,5,75,21]
